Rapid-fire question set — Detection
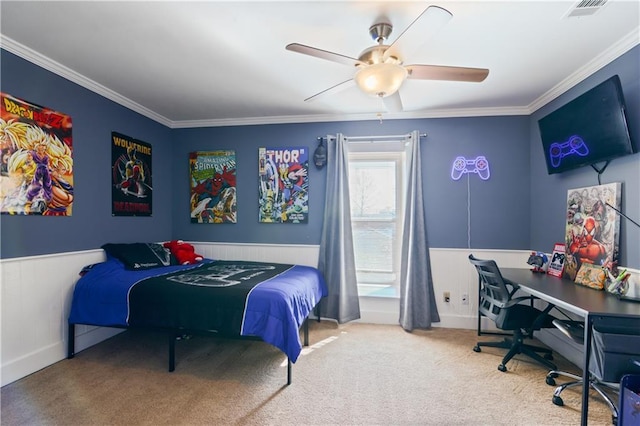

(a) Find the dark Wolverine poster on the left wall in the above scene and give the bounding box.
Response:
[111,132,153,216]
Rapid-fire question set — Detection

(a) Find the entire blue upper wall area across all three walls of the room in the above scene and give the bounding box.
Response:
[0,47,640,268]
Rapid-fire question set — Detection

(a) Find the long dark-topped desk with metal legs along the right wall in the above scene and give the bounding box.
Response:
[500,268,640,426]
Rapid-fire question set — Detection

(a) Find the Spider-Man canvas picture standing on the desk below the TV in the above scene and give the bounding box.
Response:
[564,182,622,280]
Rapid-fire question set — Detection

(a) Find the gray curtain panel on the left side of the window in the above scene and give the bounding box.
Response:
[318,134,360,323]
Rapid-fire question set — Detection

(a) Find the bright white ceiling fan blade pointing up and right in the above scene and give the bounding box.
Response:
[384,6,453,59]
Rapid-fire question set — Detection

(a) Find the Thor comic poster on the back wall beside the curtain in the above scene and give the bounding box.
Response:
[258,147,309,223]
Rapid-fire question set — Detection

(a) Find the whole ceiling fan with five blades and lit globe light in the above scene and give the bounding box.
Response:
[286,6,489,112]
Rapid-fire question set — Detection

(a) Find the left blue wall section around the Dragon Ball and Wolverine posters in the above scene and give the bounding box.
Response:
[0,50,173,259]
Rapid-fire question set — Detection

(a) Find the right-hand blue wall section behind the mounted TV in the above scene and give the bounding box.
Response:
[529,46,640,269]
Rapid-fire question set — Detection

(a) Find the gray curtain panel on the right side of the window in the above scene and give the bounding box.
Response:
[400,131,440,331]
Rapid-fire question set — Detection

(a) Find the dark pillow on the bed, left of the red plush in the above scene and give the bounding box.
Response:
[102,243,177,271]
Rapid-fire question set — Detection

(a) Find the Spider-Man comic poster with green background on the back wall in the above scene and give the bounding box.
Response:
[189,151,237,223]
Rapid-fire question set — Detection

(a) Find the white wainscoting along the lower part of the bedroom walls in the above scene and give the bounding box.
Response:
[0,242,529,385]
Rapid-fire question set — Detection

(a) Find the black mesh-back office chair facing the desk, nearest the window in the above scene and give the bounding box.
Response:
[469,254,556,372]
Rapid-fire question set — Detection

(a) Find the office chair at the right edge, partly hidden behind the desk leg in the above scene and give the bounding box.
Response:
[546,317,640,424]
